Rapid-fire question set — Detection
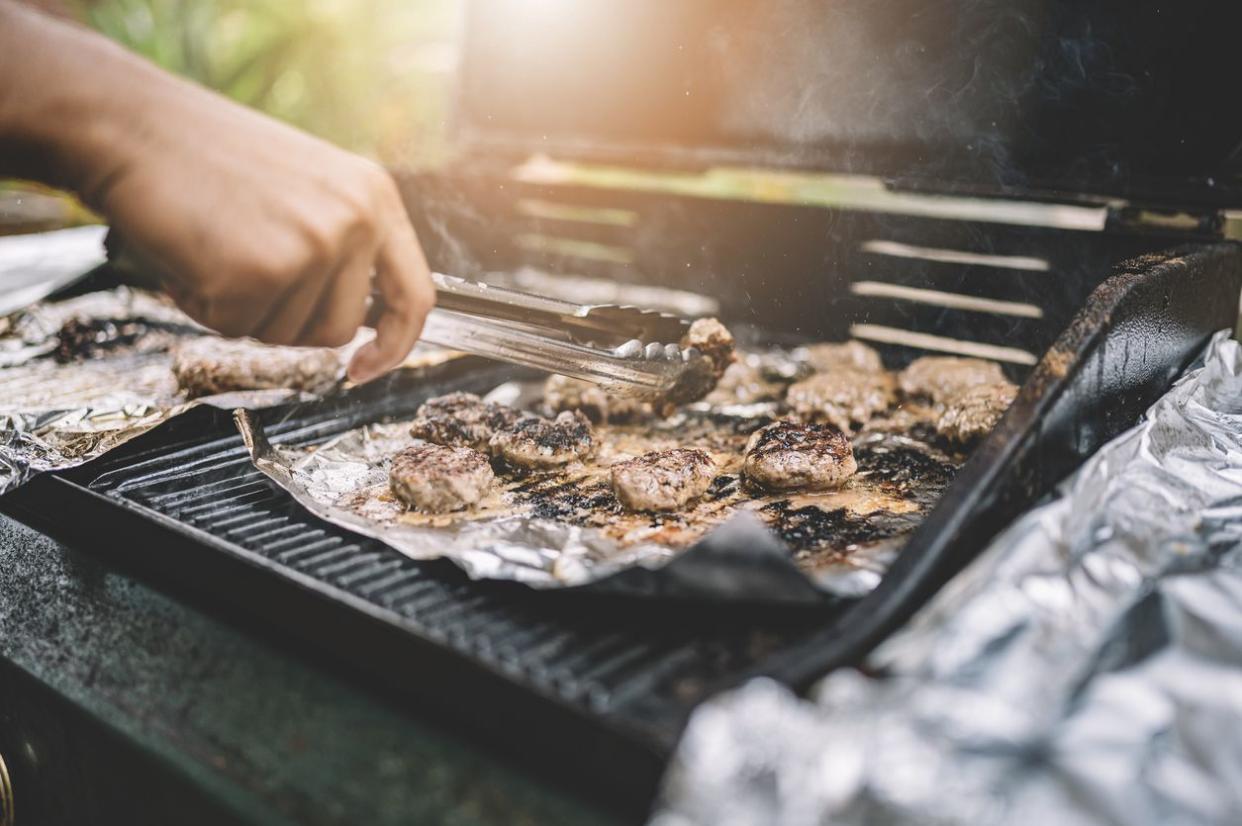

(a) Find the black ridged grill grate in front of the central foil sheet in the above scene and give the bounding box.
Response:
[89,420,822,742]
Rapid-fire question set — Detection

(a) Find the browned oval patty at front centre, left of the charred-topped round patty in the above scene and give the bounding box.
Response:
[612,447,715,511]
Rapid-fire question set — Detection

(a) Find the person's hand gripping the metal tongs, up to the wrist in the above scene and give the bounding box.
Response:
[94,83,435,381]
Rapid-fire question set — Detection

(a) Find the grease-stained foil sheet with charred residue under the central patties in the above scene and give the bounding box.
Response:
[237,372,961,601]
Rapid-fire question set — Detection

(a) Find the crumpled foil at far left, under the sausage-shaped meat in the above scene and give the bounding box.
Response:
[0,287,330,494]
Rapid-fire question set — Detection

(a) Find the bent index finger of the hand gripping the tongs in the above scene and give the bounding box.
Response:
[349,217,436,383]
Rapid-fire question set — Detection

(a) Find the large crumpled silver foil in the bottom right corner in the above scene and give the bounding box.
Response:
[652,332,1242,826]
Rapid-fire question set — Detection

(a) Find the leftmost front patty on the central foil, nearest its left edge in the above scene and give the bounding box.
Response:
[389,443,496,513]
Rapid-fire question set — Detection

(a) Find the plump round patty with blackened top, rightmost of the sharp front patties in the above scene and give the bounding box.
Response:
[741,421,858,491]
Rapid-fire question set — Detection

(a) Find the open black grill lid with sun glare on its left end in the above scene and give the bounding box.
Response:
[458,0,1242,206]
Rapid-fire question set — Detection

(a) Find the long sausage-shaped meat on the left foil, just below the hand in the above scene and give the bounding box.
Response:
[173,335,340,397]
